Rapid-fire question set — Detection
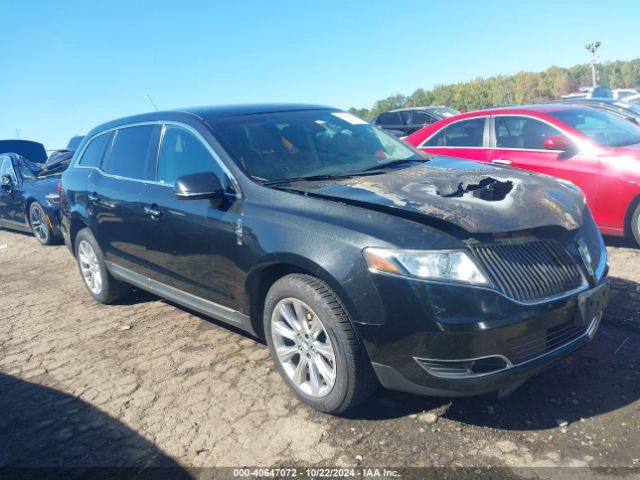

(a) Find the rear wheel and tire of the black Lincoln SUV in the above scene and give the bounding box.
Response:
[75,228,132,304]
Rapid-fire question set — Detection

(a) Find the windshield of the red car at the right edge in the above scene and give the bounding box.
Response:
[549,108,640,147]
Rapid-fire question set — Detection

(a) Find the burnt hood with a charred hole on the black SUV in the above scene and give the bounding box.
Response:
[288,156,585,233]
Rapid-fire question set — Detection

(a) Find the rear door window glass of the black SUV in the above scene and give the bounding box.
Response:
[104,125,158,180]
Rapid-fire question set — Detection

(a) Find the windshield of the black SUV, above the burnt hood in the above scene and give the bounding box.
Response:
[208,110,429,182]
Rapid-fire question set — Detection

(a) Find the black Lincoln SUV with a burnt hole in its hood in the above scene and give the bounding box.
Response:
[61,105,608,413]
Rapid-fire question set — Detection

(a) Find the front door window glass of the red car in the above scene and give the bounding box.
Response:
[495,116,560,150]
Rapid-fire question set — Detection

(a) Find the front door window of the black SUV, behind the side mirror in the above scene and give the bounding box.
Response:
[157,125,226,186]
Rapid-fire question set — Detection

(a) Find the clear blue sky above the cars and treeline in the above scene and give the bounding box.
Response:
[0,0,640,149]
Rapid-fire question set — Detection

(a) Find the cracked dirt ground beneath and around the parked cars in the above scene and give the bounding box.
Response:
[0,230,640,478]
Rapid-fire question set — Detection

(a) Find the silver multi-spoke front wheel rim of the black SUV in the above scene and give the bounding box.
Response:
[271,298,336,398]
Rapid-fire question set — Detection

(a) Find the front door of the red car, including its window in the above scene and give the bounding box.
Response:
[490,115,600,206]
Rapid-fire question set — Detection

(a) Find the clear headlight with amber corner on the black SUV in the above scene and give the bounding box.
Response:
[363,248,489,285]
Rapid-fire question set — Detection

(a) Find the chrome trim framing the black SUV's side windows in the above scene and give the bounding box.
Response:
[72,120,242,198]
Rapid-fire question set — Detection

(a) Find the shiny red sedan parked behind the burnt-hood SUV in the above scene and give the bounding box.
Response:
[405,104,640,248]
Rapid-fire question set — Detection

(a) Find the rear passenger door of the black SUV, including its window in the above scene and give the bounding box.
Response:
[81,124,160,274]
